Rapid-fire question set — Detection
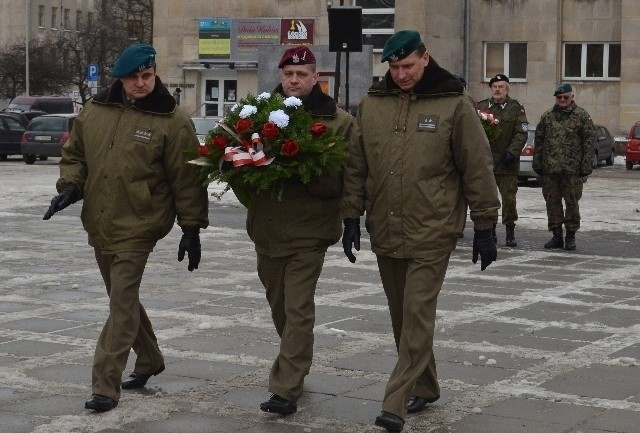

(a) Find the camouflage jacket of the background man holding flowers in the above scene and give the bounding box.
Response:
[477,96,528,176]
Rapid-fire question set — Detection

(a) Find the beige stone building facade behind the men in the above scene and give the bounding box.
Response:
[154,0,640,134]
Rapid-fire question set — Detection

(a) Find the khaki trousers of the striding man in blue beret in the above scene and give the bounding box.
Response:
[92,248,164,401]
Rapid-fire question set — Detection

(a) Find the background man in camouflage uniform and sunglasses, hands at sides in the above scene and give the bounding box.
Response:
[533,83,595,250]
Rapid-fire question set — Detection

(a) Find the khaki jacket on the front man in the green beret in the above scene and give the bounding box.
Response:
[341,58,500,258]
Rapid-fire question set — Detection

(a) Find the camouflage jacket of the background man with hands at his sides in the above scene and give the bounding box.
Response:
[533,102,595,176]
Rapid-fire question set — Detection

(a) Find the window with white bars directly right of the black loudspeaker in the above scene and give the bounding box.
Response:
[356,0,396,53]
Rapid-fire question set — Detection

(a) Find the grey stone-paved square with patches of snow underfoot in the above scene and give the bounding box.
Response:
[0,166,640,433]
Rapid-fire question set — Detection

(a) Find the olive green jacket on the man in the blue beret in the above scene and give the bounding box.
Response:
[56,77,208,252]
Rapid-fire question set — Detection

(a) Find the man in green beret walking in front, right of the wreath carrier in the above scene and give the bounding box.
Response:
[341,30,500,432]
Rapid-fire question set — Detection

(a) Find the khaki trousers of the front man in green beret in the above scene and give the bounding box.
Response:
[377,254,450,419]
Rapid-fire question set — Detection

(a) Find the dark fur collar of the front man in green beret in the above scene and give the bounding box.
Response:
[369,57,464,97]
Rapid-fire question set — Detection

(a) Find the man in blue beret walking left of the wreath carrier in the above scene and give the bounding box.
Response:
[44,44,208,412]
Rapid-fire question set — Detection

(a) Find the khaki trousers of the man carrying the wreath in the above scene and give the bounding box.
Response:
[258,249,326,402]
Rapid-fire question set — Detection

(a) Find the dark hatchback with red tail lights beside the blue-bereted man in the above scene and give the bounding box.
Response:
[21,114,77,164]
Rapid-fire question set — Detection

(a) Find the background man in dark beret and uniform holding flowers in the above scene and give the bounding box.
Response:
[477,74,528,247]
